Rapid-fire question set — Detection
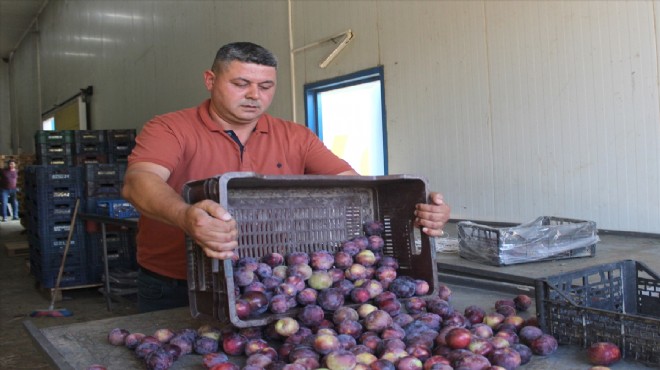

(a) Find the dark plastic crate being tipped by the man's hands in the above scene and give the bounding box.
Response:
[183,172,438,327]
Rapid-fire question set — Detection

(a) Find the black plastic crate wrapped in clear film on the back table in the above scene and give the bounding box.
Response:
[457,216,599,266]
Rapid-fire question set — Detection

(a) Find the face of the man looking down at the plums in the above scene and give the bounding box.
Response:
[204,61,277,125]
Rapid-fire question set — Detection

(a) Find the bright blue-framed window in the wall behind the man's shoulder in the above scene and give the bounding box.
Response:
[305,66,387,176]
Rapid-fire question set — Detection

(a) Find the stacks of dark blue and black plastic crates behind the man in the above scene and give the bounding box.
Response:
[25,130,136,288]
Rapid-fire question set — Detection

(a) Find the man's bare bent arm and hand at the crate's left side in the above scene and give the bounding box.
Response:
[122,162,238,259]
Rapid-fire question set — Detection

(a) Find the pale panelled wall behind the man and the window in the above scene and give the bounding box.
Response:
[3,0,660,233]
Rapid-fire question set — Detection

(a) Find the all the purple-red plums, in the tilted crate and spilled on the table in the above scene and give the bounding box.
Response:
[96,221,620,370]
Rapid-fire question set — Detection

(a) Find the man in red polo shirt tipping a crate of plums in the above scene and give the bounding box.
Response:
[122,42,449,312]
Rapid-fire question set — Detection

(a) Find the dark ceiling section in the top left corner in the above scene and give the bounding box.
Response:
[0,0,48,61]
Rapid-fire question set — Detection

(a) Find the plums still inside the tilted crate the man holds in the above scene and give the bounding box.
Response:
[233,221,430,320]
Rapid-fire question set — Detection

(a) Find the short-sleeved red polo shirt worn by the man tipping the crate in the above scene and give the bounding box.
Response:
[128,100,352,279]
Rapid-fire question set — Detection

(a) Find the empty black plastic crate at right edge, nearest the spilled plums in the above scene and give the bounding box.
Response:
[536,260,660,366]
